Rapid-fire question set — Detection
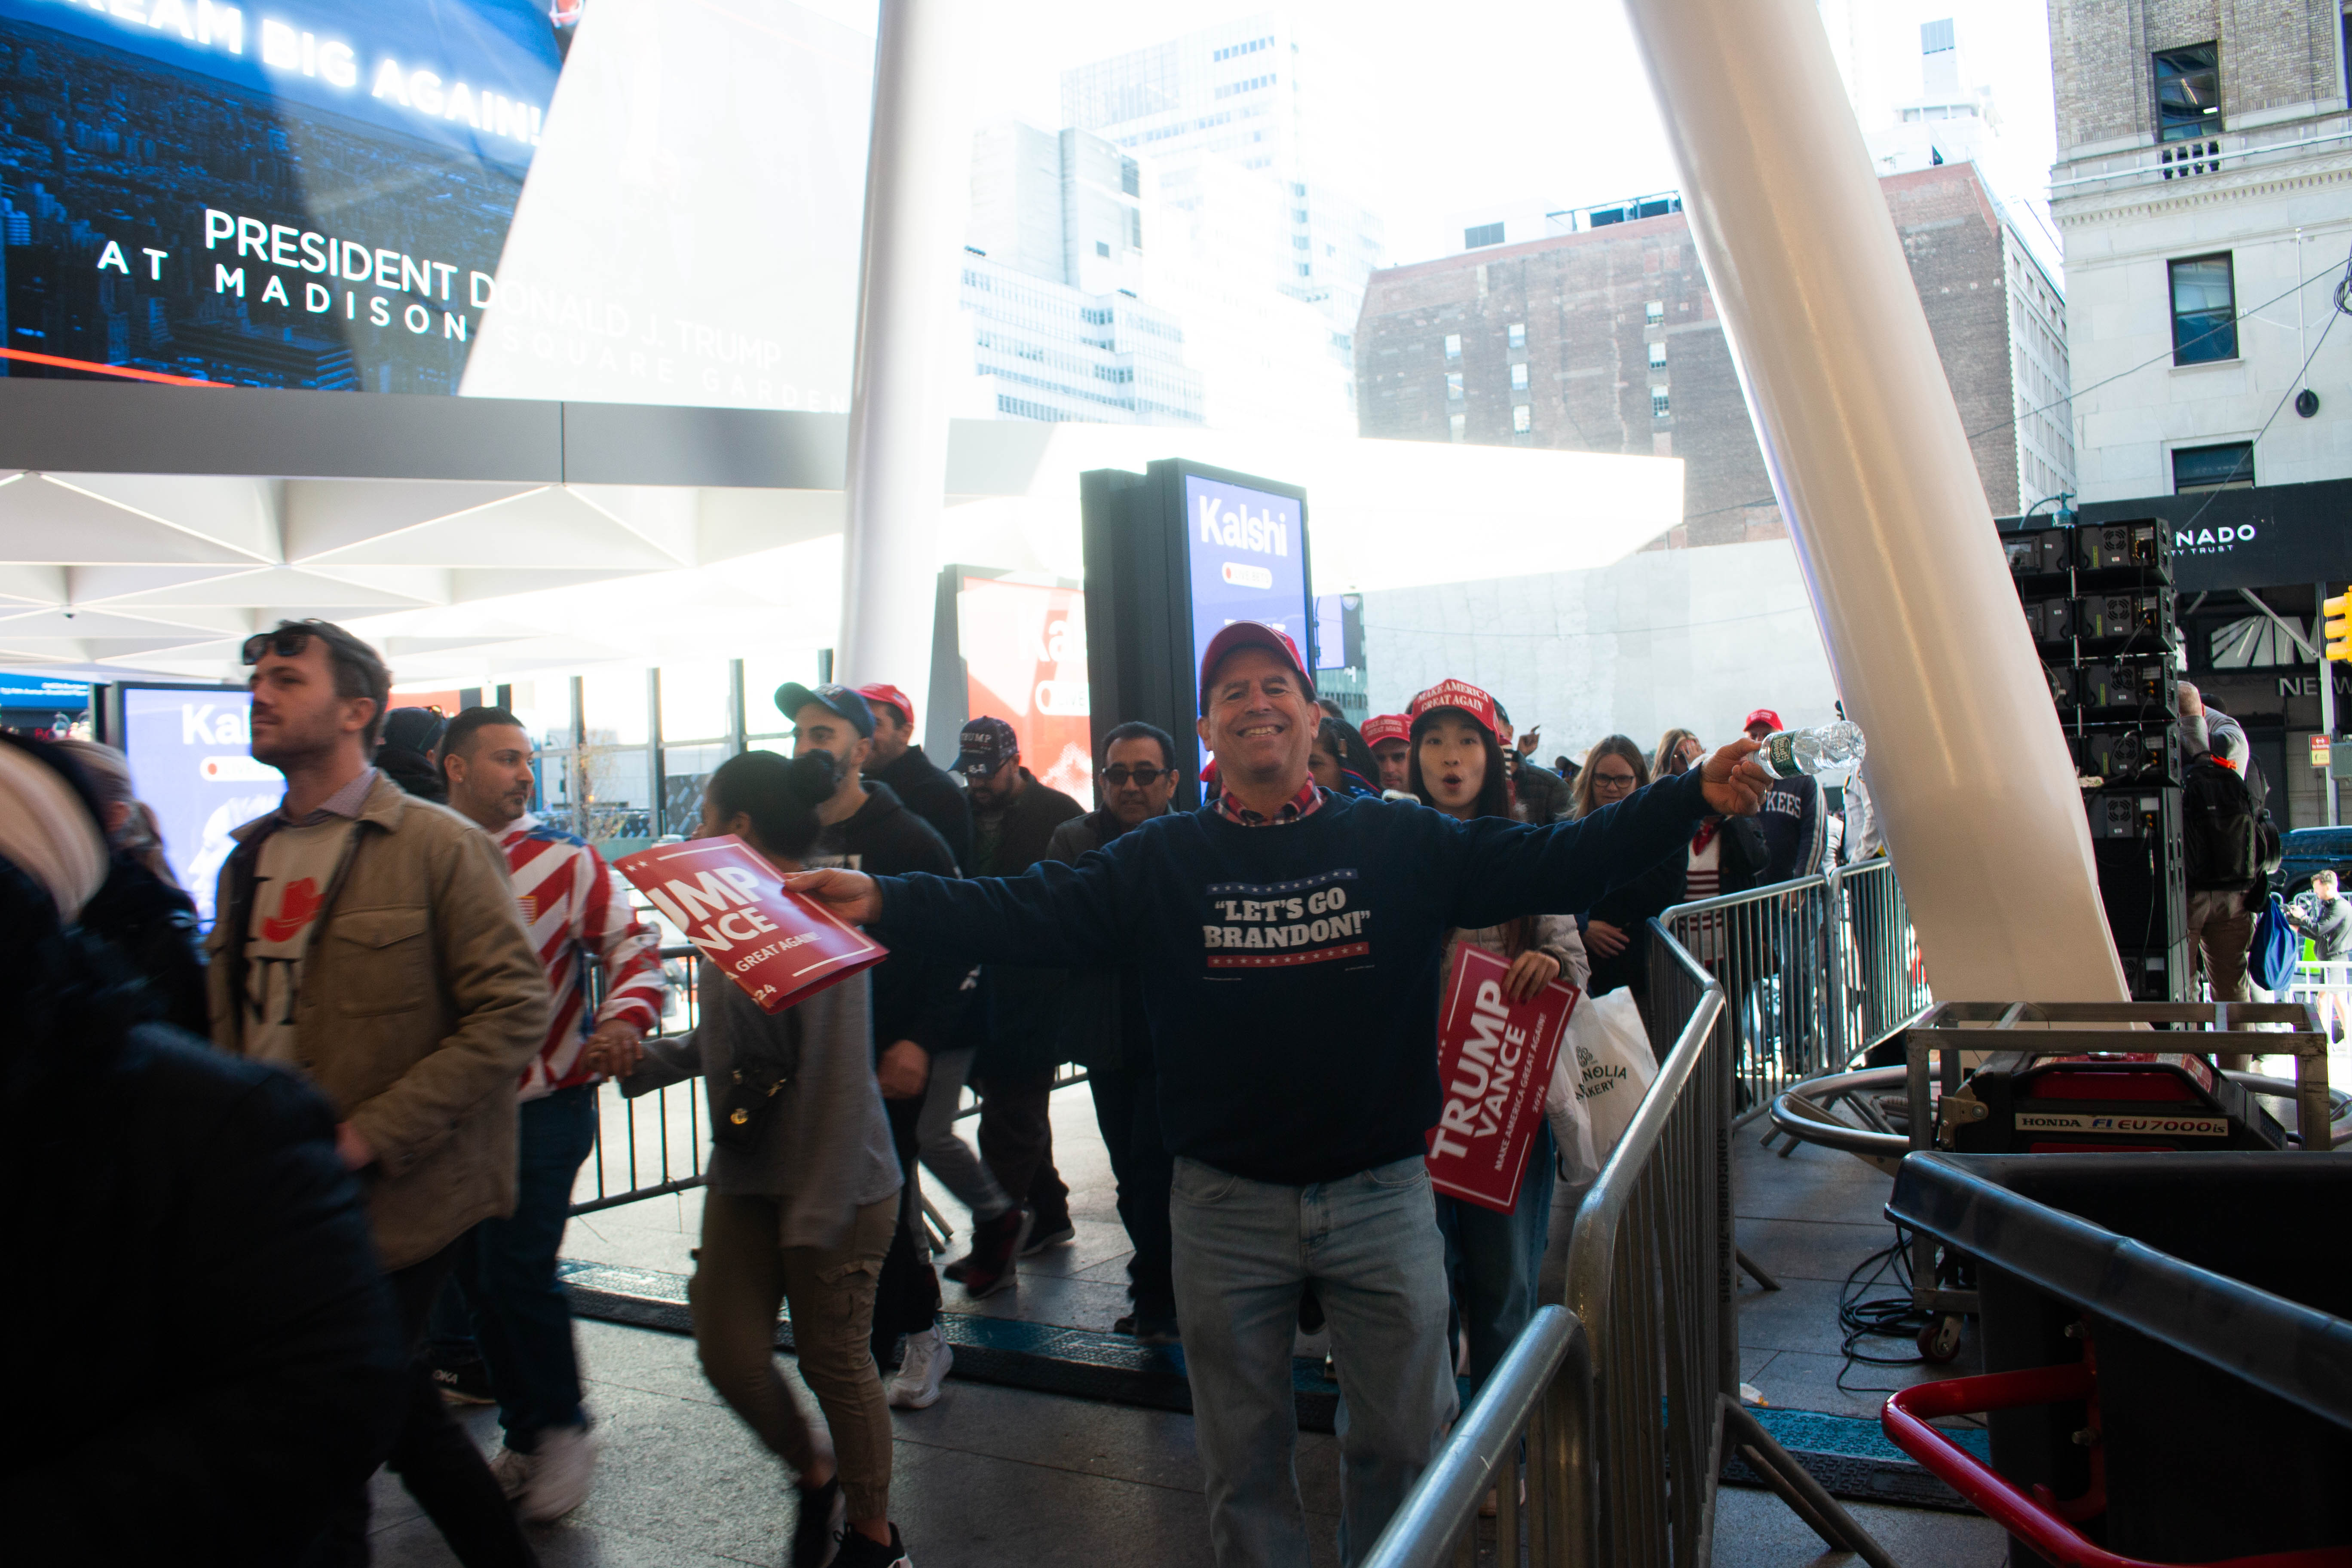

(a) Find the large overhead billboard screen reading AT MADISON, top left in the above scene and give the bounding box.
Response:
[0,0,873,409]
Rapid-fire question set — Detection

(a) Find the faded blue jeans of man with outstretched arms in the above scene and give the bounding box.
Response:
[1169,1157,1456,1568]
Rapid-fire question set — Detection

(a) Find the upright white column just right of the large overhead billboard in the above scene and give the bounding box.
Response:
[833,0,971,691]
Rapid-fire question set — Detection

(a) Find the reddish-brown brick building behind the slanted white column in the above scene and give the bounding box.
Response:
[1357,162,2072,548]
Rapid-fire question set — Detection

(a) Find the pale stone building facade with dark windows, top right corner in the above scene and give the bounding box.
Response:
[2051,0,2352,501]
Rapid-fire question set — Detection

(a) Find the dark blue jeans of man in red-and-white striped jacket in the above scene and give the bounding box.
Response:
[435,1084,597,1453]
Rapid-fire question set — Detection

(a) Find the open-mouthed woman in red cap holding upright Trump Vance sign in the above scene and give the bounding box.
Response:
[1406,682,1585,1389]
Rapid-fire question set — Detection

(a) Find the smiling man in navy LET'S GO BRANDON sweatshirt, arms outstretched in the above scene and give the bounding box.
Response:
[793,623,1771,1568]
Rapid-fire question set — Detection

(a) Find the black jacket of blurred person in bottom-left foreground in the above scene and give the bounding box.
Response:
[0,907,407,1568]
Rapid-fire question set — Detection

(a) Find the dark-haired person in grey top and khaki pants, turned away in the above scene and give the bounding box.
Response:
[621,752,906,1568]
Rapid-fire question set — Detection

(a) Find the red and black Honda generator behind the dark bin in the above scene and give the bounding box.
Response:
[1938,1039,2288,1154]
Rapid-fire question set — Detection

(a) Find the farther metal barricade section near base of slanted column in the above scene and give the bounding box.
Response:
[1658,858,1931,1124]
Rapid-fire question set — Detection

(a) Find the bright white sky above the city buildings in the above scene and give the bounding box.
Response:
[812,0,2053,276]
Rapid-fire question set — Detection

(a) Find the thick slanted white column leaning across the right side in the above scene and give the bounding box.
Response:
[1625,0,2124,1001]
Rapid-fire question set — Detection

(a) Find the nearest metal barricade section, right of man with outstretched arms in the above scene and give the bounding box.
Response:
[1366,922,1891,1568]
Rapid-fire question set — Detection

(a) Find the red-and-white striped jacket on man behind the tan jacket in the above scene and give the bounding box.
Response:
[499,813,663,1100]
